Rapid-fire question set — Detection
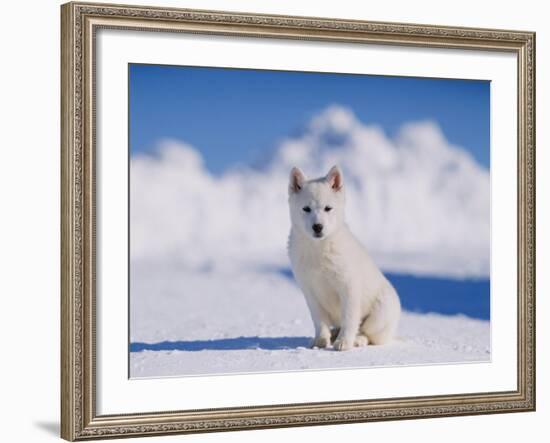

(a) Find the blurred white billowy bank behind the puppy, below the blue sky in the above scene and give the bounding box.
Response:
[131,106,490,276]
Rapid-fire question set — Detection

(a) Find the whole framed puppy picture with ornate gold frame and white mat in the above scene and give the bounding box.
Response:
[61,2,535,441]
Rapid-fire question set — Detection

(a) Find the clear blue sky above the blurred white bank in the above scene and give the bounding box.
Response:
[129,64,490,173]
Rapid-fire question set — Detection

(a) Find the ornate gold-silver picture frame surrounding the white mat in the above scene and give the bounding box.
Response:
[61,3,535,441]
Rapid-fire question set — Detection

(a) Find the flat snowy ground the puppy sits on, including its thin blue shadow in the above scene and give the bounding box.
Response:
[130,264,490,377]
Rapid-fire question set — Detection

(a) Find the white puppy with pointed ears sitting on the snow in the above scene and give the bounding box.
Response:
[288,166,401,351]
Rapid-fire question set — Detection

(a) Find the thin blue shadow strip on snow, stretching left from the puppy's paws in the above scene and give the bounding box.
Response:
[130,337,311,352]
